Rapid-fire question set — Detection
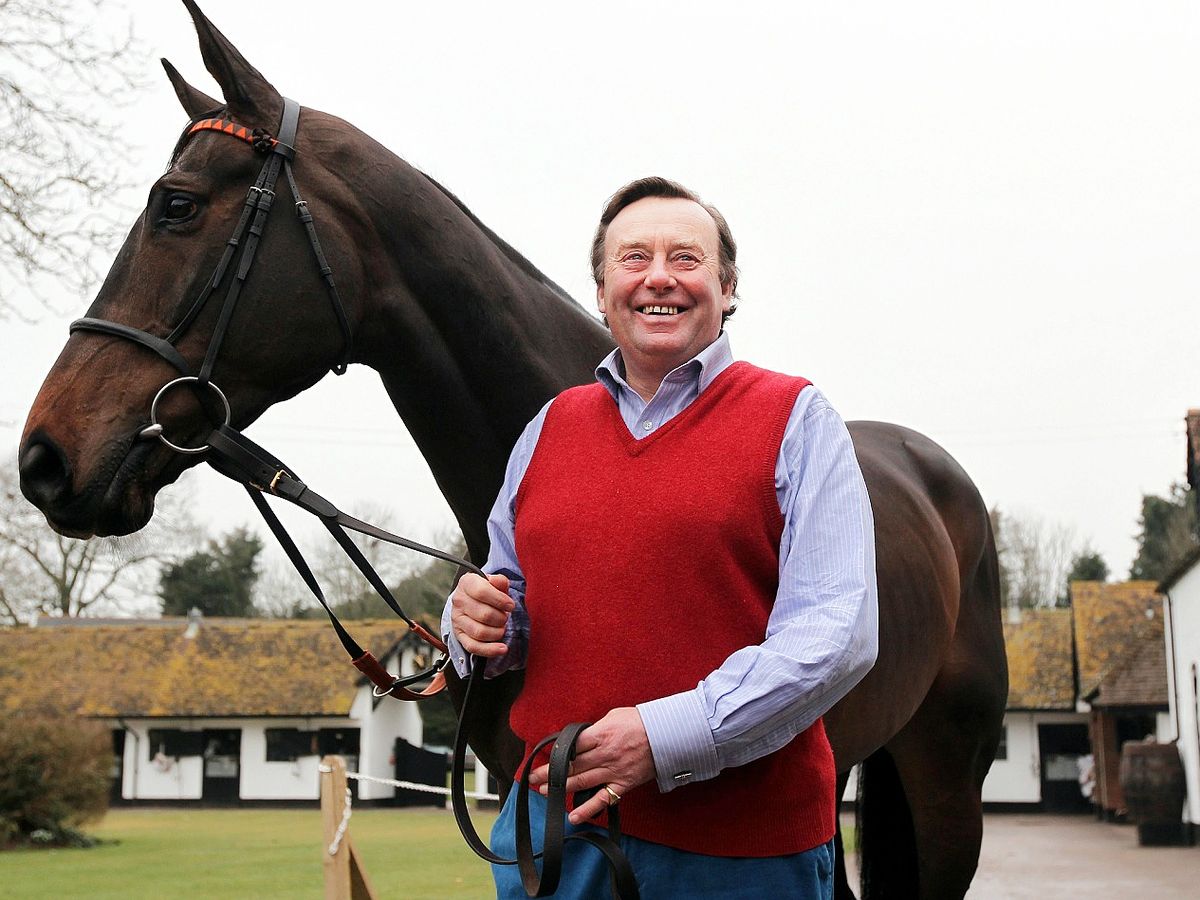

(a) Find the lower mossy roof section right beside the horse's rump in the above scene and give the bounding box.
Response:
[1004,610,1075,709]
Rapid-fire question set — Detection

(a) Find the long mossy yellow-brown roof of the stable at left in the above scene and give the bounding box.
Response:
[0,618,409,716]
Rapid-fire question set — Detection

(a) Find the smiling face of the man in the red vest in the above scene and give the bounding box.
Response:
[596,197,732,389]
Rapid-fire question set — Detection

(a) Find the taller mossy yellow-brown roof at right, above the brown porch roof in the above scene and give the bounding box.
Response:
[1070,581,1166,697]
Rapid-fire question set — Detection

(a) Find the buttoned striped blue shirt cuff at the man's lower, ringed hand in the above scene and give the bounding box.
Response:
[637,691,721,793]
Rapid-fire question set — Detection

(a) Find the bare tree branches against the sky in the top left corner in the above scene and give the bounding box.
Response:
[0,0,145,318]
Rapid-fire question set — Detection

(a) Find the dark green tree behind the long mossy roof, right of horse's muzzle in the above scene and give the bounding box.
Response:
[158,528,263,616]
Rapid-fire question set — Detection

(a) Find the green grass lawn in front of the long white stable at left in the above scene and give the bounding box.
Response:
[0,808,496,900]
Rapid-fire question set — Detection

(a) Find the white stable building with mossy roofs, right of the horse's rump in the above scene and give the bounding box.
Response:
[983,581,1174,818]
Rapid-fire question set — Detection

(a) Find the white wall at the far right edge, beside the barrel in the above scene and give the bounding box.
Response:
[1166,565,1200,824]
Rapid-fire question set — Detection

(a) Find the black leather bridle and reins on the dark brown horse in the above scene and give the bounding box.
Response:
[71,97,638,900]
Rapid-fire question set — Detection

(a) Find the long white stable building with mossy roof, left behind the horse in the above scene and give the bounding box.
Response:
[0,616,439,804]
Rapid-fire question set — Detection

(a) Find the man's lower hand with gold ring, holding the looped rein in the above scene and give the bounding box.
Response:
[529,707,654,824]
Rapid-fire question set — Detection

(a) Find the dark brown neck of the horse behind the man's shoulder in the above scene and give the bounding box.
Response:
[345,160,612,556]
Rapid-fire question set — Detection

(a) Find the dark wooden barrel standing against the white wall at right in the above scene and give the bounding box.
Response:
[1120,740,1187,847]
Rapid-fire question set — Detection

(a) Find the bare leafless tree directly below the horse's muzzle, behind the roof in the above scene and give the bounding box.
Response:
[0,456,199,625]
